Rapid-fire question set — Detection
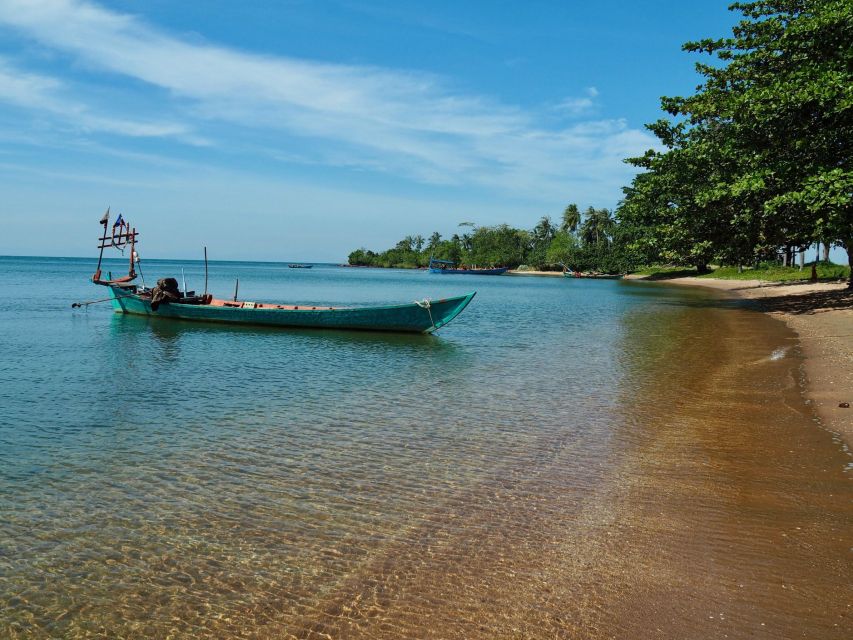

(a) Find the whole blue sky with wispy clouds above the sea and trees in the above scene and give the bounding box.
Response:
[0,0,736,261]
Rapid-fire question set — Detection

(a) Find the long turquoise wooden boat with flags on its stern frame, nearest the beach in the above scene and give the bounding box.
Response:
[81,211,476,333]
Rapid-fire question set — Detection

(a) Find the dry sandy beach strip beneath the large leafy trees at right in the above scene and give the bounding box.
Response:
[631,277,853,449]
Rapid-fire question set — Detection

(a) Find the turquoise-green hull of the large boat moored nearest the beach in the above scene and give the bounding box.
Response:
[109,286,476,333]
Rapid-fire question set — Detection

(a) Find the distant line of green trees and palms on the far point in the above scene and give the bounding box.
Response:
[349,204,644,273]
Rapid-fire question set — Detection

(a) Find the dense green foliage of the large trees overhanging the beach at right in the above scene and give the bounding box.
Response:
[618,0,853,284]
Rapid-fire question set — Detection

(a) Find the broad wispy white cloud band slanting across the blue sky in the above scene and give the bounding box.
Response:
[0,0,652,197]
